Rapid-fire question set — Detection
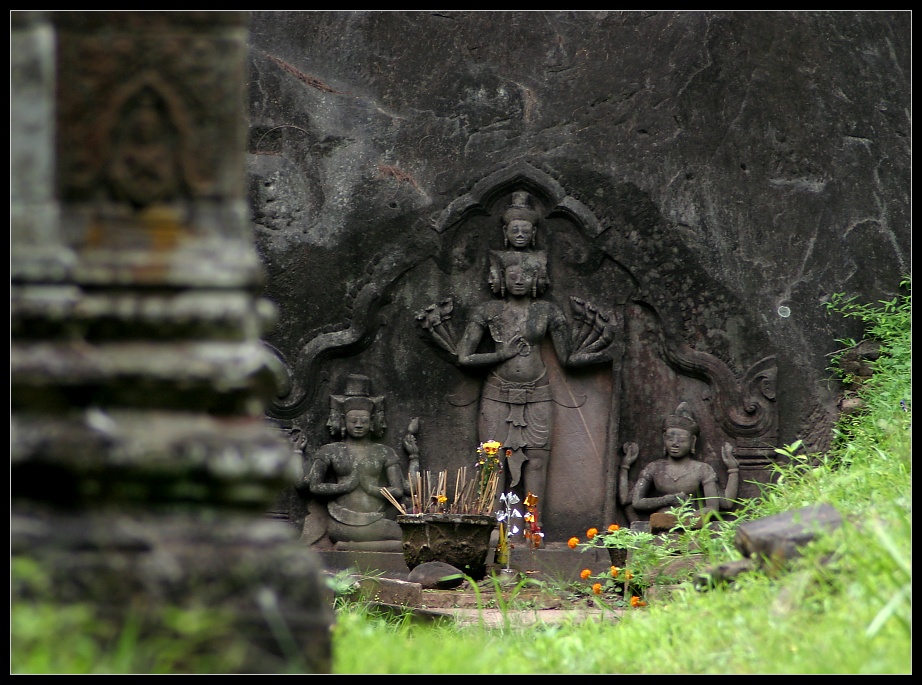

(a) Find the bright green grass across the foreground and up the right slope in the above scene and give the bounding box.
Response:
[10,280,912,674]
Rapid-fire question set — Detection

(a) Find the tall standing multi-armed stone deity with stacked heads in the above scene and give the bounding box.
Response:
[417,192,617,528]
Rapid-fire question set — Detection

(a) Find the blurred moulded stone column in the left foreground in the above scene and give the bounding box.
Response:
[10,11,333,672]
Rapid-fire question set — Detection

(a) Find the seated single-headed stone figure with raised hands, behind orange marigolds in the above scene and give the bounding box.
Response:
[619,402,739,514]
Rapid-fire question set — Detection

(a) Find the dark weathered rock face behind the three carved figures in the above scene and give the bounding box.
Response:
[247,11,911,540]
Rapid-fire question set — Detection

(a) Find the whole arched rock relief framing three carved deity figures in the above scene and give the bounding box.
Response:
[269,165,778,547]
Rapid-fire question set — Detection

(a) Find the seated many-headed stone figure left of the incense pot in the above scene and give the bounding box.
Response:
[298,375,404,551]
